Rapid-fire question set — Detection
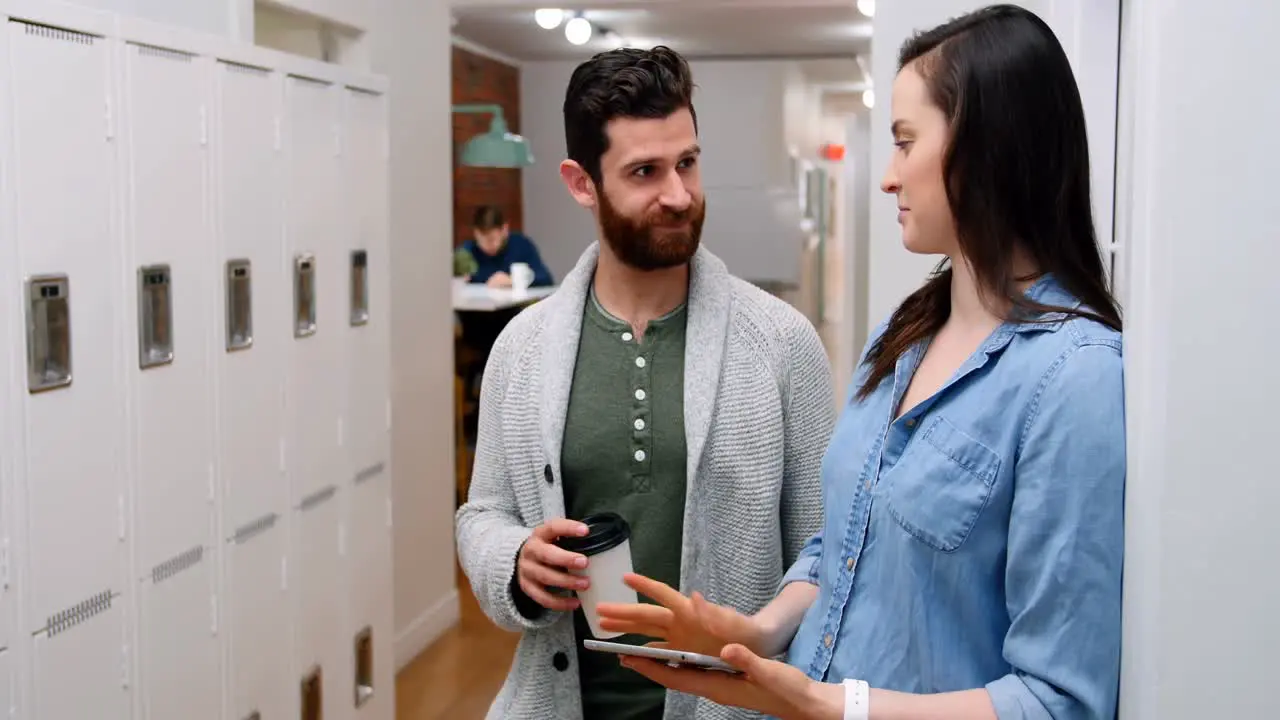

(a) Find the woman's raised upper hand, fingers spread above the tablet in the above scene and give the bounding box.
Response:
[596,574,772,656]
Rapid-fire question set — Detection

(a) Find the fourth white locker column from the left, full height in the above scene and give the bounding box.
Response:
[284,77,349,720]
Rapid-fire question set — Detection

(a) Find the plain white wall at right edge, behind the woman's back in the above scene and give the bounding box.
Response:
[1117,0,1280,720]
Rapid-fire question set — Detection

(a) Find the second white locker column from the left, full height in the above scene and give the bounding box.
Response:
[123,44,221,720]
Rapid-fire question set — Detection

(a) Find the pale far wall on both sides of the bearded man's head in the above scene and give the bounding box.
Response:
[520,60,818,281]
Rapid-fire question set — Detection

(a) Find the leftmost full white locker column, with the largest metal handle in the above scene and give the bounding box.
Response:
[8,22,131,720]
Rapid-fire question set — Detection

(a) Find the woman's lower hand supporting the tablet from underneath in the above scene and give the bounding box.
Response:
[622,644,845,720]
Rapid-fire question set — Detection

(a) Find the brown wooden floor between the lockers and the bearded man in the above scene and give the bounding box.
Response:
[396,573,520,720]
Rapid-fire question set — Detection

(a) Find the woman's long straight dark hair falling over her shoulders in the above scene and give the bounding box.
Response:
[858,5,1120,398]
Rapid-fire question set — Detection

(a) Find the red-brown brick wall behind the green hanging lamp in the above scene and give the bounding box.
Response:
[453,46,525,245]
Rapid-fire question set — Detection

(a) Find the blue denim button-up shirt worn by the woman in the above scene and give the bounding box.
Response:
[785,277,1125,720]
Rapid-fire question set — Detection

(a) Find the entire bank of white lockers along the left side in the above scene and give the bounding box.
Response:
[0,3,394,720]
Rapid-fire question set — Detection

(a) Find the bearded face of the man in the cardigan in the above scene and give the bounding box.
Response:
[595,109,707,270]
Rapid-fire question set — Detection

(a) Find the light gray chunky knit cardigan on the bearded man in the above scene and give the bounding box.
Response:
[457,245,836,720]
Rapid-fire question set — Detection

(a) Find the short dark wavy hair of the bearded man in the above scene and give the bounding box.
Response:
[564,45,698,186]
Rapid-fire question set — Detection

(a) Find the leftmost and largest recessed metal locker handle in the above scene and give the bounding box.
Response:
[27,274,72,393]
